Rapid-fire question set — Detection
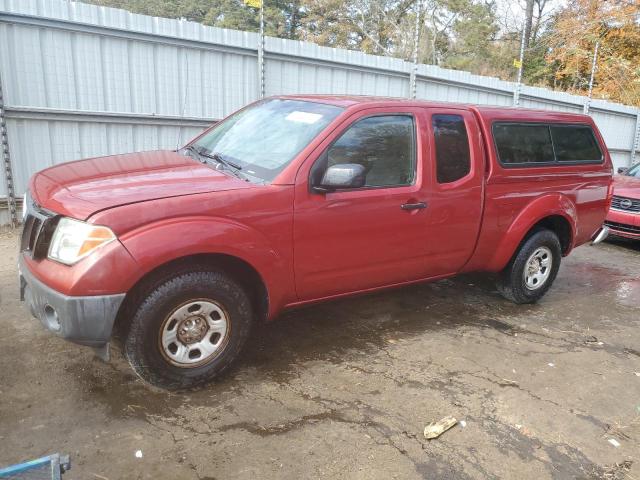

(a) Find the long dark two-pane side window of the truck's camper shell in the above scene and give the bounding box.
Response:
[492,121,604,167]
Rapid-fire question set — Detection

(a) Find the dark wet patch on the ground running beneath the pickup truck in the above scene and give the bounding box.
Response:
[60,263,640,418]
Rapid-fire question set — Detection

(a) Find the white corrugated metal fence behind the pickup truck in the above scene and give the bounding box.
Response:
[0,0,640,223]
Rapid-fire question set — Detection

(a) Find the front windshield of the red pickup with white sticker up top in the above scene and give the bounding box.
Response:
[193,99,343,182]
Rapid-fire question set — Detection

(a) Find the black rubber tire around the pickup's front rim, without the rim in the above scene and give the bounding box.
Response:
[124,271,253,389]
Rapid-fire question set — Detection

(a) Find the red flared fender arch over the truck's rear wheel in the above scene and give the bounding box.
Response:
[487,193,578,272]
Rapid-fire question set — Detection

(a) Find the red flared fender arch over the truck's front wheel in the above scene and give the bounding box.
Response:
[120,216,295,316]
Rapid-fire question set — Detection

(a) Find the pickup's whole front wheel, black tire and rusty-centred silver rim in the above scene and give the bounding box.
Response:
[124,271,253,389]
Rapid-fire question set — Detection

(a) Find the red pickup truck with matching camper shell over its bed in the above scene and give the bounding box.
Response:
[19,96,612,388]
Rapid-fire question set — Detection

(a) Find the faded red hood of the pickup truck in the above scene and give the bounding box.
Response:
[29,151,251,219]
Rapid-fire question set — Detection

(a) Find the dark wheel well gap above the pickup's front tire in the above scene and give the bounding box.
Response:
[114,254,269,335]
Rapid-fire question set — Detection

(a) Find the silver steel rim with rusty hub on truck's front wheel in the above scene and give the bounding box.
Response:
[160,299,230,367]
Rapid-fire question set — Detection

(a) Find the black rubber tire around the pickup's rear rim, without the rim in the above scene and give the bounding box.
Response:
[497,229,562,304]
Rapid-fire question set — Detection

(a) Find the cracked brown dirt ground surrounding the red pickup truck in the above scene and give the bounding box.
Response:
[0,232,640,480]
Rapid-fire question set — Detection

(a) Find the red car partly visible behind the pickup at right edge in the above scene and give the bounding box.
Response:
[605,163,640,240]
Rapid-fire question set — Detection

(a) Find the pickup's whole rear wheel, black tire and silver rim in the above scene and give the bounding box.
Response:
[497,229,562,304]
